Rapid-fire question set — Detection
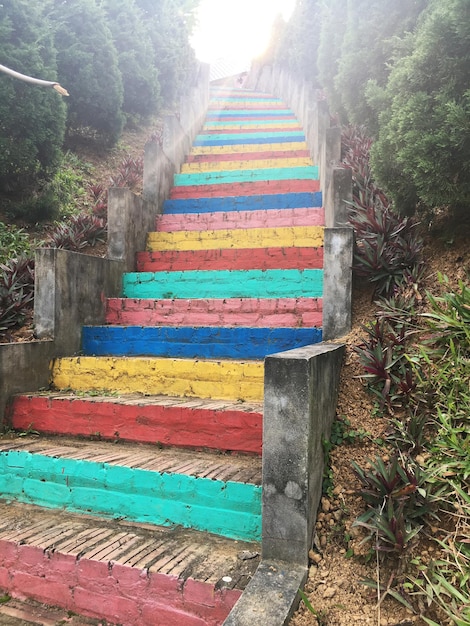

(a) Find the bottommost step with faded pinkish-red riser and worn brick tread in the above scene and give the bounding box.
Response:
[0,501,260,626]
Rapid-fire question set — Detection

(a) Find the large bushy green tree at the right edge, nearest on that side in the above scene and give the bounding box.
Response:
[372,0,470,213]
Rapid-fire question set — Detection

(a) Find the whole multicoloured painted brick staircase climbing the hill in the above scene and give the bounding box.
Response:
[0,90,324,626]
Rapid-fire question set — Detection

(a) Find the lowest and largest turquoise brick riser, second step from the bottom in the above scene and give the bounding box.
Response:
[0,440,261,540]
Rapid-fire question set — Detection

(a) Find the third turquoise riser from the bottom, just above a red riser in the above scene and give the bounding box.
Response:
[174,164,318,187]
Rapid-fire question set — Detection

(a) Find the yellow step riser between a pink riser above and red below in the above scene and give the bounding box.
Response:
[147,226,324,252]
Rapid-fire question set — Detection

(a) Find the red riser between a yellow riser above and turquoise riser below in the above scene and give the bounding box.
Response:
[136,247,323,272]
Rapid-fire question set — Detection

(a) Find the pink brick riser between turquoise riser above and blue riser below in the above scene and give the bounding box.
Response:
[106,298,323,328]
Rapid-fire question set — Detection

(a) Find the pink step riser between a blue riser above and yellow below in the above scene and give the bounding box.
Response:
[155,207,325,232]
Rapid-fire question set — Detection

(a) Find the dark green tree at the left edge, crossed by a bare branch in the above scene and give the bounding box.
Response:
[0,0,65,192]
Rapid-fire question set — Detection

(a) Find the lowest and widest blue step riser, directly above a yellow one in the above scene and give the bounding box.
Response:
[82,326,321,360]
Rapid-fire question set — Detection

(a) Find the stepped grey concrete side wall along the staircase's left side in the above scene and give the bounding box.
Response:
[0,64,209,425]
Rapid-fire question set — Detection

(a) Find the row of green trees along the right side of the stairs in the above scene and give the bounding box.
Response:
[262,0,470,215]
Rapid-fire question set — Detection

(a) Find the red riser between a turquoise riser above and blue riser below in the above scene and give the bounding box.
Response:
[170,180,320,200]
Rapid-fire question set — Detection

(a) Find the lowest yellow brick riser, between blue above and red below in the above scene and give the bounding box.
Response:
[52,356,264,402]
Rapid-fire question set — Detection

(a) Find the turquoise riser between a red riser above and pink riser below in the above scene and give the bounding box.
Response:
[123,269,323,299]
